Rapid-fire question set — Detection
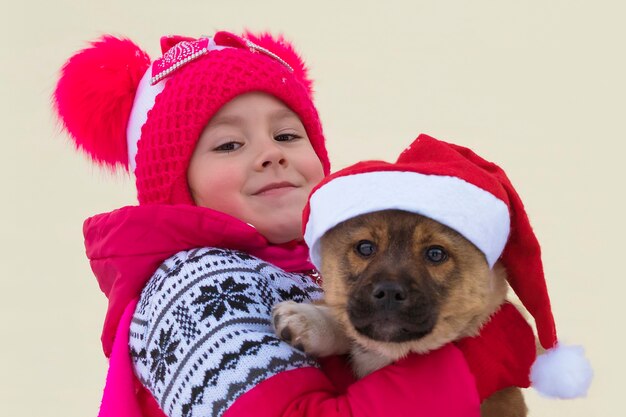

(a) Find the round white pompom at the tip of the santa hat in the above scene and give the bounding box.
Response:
[530,344,593,398]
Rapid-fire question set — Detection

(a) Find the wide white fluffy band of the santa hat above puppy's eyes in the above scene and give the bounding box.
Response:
[304,171,510,268]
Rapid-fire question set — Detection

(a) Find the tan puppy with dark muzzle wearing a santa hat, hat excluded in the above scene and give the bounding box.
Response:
[274,210,527,417]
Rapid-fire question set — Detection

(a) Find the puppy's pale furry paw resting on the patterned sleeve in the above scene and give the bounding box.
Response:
[272,301,346,357]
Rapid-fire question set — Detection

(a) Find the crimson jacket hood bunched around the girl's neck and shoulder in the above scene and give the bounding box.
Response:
[83,205,313,356]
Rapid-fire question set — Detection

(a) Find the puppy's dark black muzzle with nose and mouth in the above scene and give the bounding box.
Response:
[348,281,438,343]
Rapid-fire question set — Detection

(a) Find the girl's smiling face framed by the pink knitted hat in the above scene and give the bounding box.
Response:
[187,93,324,244]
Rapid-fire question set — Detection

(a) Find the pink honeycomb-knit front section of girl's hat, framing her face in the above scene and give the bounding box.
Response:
[135,38,330,204]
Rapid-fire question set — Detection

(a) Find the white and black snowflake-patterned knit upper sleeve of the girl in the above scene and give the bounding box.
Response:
[130,248,322,417]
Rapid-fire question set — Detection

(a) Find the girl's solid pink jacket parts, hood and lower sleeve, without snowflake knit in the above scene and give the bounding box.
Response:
[84,205,534,417]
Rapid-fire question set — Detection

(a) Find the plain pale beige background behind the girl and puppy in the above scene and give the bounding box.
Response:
[0,0,626,417]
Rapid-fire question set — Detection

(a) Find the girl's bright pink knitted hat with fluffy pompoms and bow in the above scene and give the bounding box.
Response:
[53,32,330,204]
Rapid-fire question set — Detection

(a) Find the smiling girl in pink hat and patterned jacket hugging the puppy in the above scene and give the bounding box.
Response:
[54,32,512,417]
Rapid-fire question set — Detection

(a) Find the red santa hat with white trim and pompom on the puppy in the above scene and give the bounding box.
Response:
[303,135,592,398]
